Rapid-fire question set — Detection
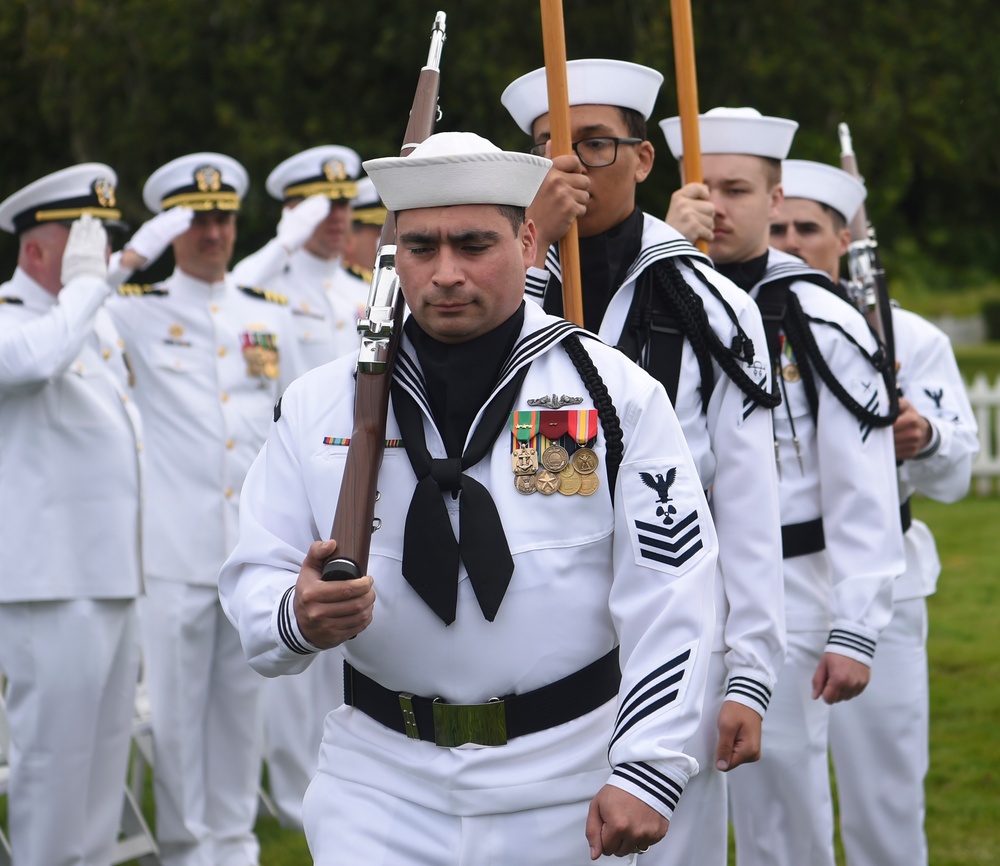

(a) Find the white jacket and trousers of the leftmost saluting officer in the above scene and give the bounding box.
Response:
[0,268,142,866]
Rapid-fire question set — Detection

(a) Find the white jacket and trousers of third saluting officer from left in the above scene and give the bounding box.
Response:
[233,241,369,827]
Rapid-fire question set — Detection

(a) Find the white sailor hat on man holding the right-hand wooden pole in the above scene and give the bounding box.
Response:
[660,108,799,159]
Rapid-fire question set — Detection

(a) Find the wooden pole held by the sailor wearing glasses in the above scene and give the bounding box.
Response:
[540,0,583,327]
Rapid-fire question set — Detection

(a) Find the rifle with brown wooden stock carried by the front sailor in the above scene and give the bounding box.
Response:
[323,12,445,580]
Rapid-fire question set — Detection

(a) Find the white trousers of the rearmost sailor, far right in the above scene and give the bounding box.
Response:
[830,598,929,866]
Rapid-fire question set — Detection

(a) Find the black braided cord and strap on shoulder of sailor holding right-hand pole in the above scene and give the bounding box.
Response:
[757,263,899,427]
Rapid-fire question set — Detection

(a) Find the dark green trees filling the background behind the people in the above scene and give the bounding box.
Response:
[0,0,1000,288]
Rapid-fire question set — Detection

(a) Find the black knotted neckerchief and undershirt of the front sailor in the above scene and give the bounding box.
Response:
[391,303,530,625]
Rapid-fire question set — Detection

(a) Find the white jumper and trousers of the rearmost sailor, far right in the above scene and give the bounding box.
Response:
[830,308,979,866]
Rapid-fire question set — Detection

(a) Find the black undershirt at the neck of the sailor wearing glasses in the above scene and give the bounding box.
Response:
[545,208,643,334]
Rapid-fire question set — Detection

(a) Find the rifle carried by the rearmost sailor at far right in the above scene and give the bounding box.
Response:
[837,123,896,375]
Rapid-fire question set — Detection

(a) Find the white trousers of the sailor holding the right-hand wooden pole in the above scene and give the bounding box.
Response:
[729,631,834,866]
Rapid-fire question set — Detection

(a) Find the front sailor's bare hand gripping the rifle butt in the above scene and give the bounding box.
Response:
[293,539,375,649]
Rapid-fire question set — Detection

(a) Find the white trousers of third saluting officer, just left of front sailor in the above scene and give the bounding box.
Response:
[264,650,344,830]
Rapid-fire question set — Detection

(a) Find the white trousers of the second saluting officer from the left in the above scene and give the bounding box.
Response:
[140,579,263,866]
